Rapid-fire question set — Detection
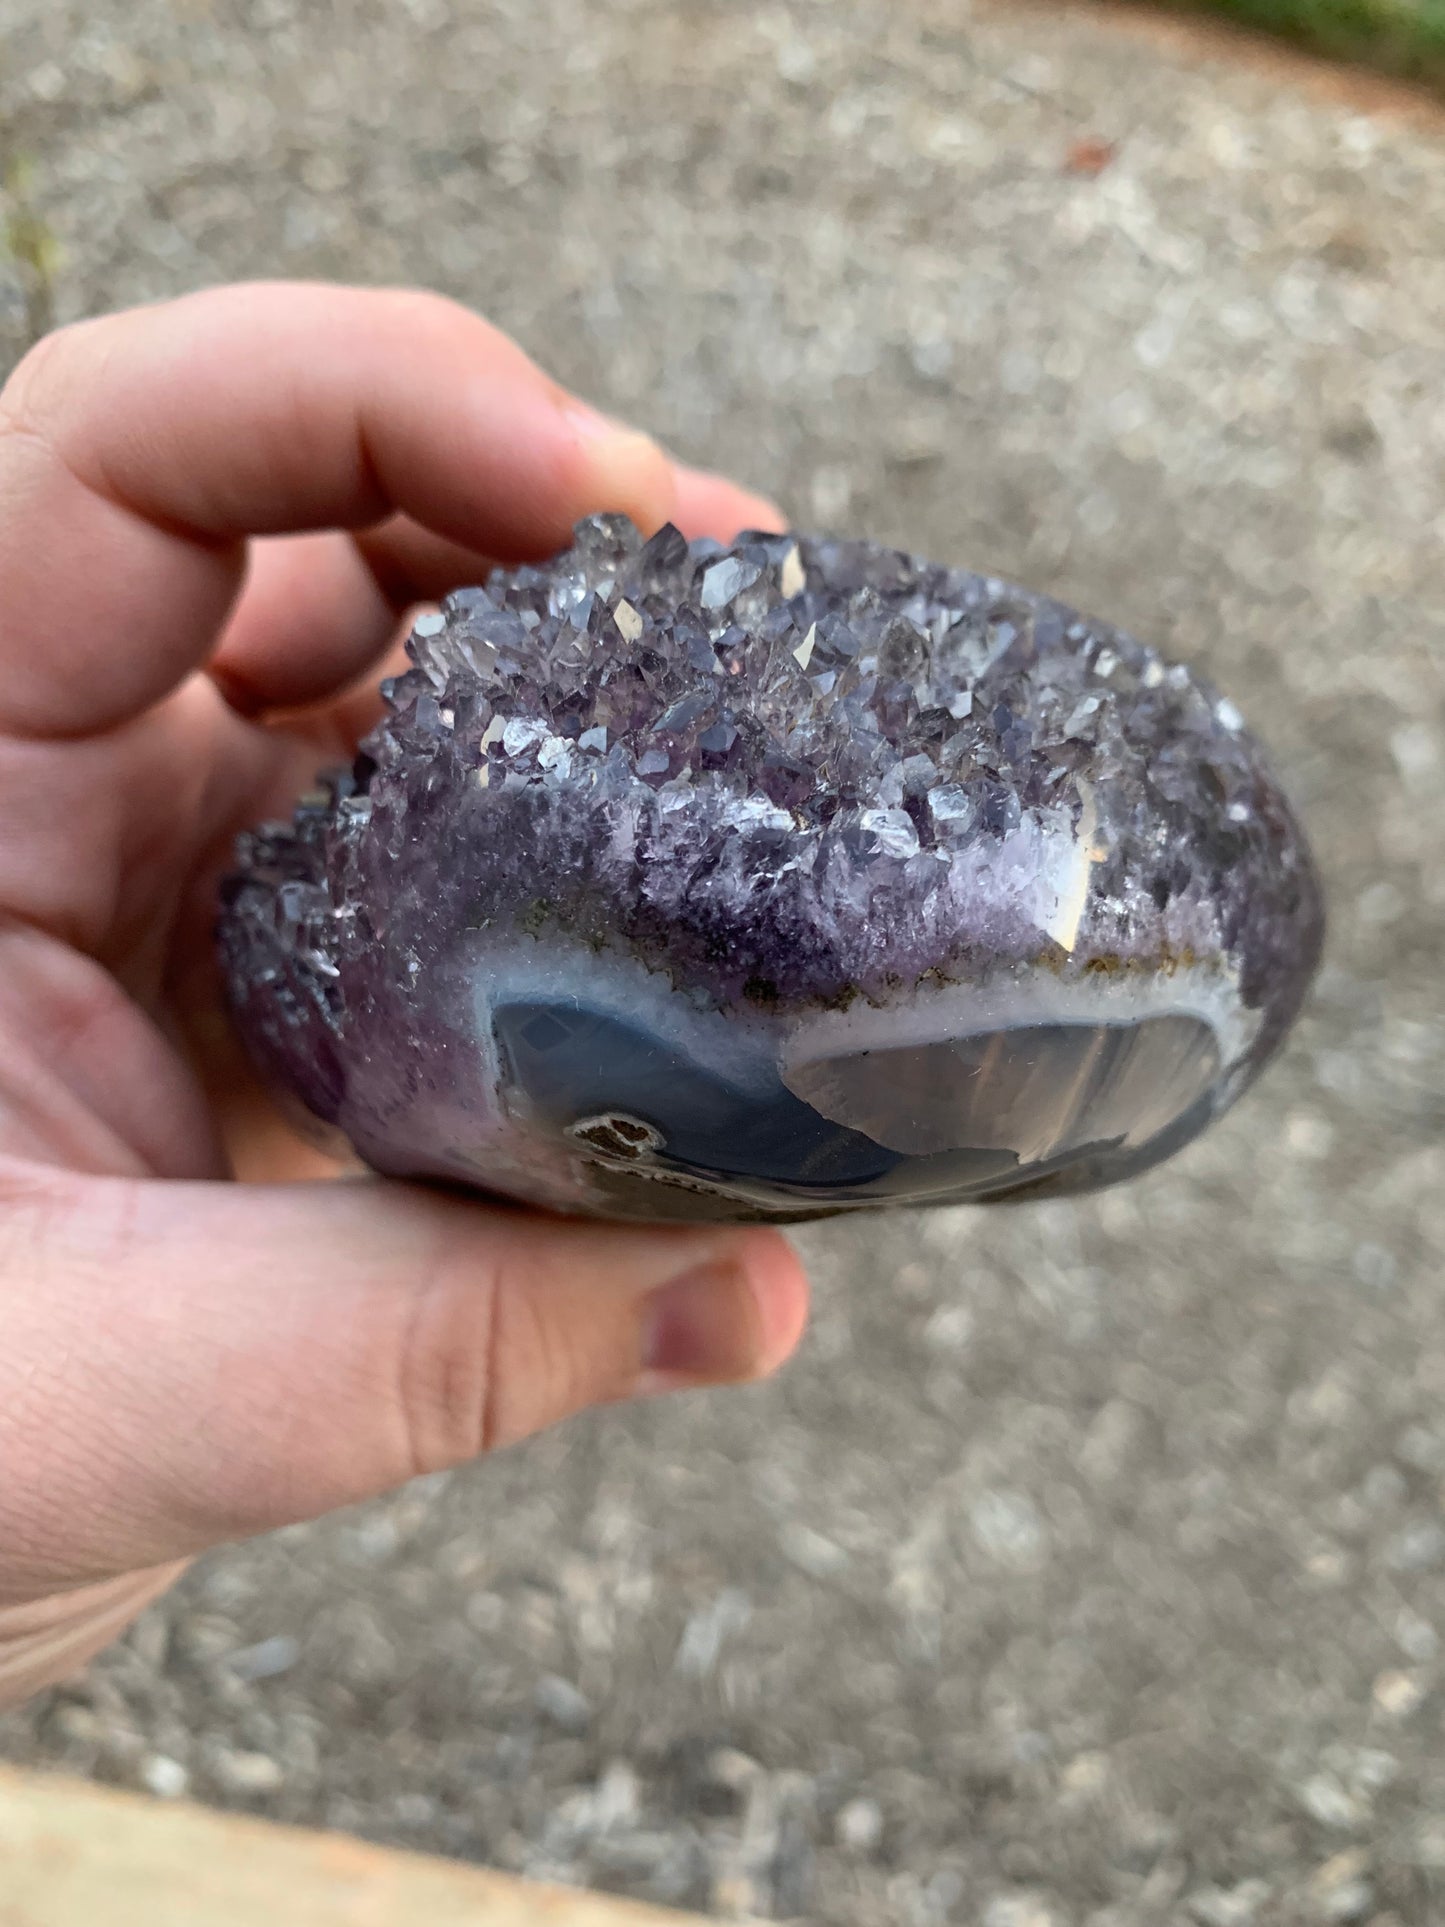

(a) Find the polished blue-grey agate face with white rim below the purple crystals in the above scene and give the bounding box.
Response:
[427,954,1243,1216]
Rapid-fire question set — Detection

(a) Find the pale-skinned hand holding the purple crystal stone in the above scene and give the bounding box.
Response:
[0,285,807,1703]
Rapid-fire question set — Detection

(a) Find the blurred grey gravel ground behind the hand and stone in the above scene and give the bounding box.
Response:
[0,0,1445,1927]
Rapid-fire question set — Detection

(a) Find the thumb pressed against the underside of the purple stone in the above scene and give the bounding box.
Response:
[0,1168,807,1605]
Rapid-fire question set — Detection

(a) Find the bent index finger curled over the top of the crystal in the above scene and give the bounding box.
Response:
[0,283,774,736]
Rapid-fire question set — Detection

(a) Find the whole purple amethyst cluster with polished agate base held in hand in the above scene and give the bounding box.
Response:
[222,518,1322,1220]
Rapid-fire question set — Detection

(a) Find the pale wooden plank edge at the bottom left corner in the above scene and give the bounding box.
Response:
[0,1767,720,1927]
